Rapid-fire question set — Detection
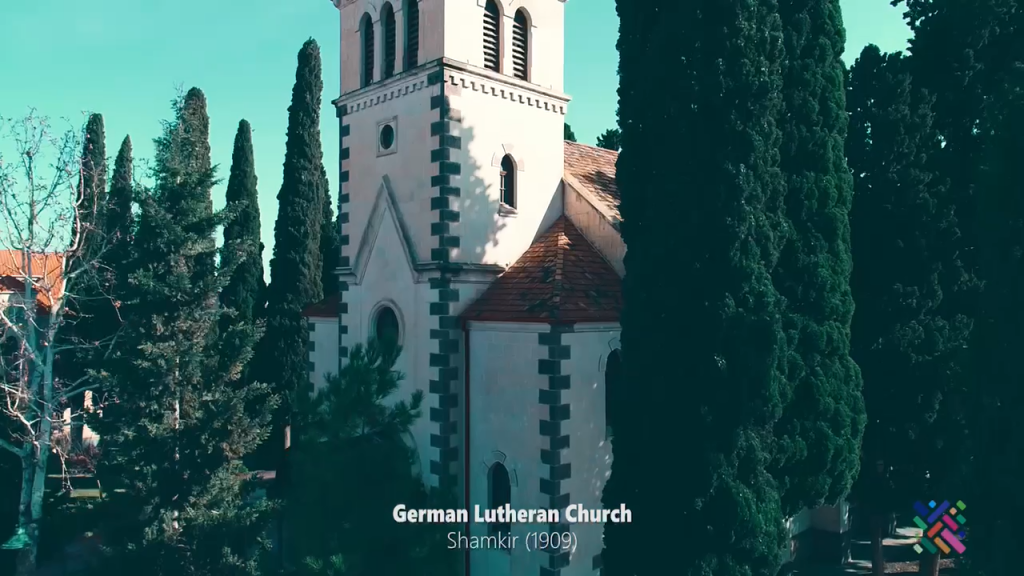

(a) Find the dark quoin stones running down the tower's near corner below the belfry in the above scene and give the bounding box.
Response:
[427,70,462,491]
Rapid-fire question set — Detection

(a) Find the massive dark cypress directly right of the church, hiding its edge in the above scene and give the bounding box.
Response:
[603,0,786,576]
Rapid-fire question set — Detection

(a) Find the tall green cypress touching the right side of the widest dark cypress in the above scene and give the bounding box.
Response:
[772,0,864,516]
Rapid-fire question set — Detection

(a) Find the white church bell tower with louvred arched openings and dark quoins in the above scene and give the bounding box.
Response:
[325,0,569,494]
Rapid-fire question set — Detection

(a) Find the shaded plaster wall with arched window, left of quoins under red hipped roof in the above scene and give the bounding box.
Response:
[469,323,548,576]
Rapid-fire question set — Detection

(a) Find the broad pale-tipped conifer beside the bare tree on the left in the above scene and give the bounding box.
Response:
[96,88,274,576]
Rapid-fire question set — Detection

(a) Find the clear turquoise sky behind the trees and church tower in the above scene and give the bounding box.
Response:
[0,0,910,272]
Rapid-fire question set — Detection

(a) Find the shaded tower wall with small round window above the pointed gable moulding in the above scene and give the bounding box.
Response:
[340,71,439,260]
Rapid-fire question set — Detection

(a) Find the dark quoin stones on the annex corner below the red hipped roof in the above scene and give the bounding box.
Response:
[537,324,573,576]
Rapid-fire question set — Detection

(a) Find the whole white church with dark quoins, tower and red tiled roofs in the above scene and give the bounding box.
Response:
[305,0,626,576]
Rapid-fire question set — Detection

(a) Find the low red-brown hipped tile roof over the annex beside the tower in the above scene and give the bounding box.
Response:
[462,216,623,323]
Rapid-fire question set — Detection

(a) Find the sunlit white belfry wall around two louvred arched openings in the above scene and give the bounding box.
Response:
[442,0,565,92]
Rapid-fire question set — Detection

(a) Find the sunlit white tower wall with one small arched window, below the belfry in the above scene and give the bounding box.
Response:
[444,69,565,265]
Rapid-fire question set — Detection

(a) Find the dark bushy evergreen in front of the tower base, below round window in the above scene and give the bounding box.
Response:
[288,340,452,576]
